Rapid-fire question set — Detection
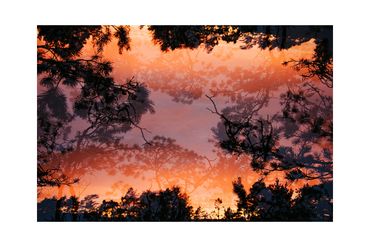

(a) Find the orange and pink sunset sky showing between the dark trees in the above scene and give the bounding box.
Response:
[38,26,331,210]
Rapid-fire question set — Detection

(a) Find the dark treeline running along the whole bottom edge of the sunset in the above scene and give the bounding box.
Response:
[37,178,333,221]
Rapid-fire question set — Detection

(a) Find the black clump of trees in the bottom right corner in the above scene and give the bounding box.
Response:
[231,178,333,221]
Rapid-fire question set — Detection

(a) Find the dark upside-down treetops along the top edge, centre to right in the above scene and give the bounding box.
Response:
[148,25,332,51]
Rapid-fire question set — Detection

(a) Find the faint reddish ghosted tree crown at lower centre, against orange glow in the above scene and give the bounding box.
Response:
[119,136,213,194]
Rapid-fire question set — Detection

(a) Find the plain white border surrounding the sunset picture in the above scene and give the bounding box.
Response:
[0,0,370,246]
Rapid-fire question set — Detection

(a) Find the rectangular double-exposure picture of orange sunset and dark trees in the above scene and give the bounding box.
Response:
[37,25,333,221]
